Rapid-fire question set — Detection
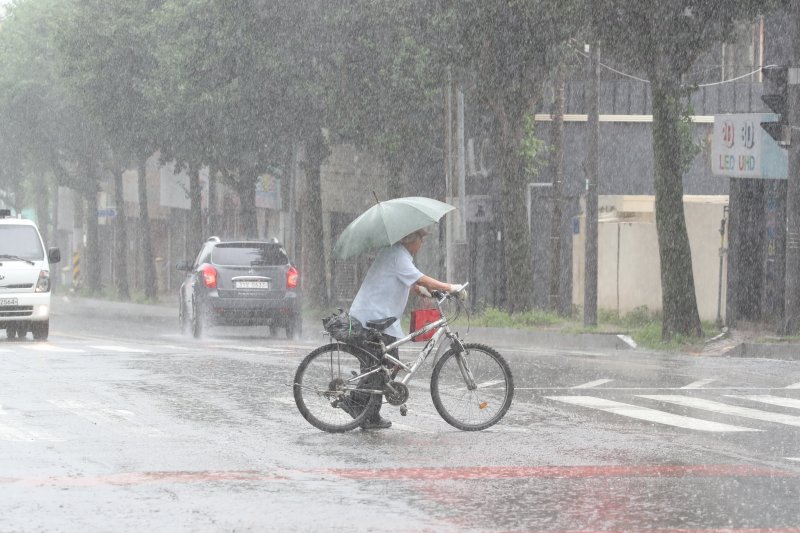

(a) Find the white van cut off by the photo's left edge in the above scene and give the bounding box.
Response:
[0,209,61,340]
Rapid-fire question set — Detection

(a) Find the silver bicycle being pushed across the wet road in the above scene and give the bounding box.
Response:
[293,285,514,433]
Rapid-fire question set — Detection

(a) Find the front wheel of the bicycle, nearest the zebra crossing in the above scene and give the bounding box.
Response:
[431,344,514,431]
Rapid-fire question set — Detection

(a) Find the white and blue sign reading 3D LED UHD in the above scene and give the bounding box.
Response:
[711,113,789,179]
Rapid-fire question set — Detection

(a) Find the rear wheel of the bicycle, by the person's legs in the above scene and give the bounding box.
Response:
[294,343,381,433]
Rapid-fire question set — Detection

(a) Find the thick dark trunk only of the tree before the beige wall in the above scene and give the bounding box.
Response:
[651,83,703,342]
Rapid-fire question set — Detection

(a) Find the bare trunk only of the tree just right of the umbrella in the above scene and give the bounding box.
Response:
[500,114,533,313]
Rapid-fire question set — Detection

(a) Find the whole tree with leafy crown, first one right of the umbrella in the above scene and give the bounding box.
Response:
[433,0,582,313]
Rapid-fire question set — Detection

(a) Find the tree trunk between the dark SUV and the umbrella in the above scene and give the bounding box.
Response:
[300,131,328,306]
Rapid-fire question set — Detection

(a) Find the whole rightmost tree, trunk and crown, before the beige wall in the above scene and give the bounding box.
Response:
[591,0,771,341]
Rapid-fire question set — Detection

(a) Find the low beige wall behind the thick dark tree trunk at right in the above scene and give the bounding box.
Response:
[572,196,728,320]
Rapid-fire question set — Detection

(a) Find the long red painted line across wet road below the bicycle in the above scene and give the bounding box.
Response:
[0,465,800,487]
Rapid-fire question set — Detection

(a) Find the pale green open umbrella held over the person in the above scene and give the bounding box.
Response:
[333,196,455,259]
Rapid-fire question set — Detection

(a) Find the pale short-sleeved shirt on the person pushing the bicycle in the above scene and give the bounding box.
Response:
[350,243,423,338]
